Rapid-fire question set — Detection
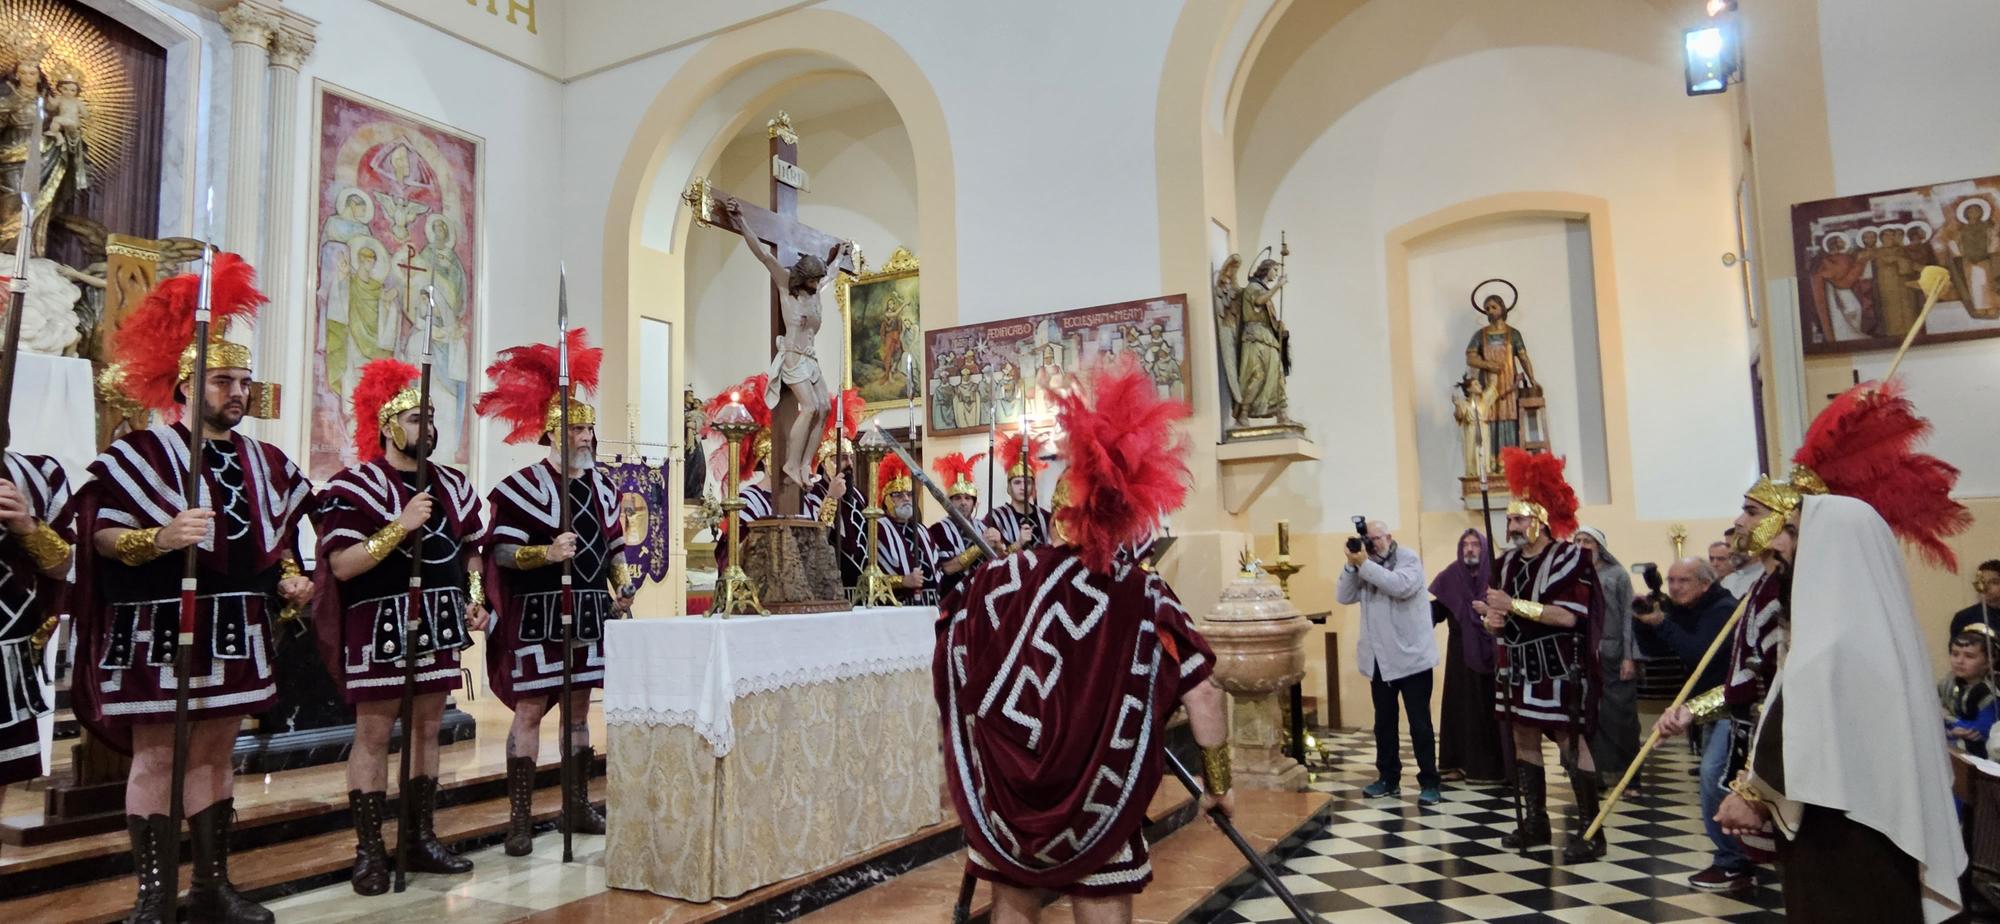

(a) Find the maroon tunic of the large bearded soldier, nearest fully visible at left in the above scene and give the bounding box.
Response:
[72,424,312,746]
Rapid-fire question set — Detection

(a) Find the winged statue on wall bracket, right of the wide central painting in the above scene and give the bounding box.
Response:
[1214,254,1290,426]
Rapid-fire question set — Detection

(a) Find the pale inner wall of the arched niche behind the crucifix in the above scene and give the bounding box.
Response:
[686,98,924,406]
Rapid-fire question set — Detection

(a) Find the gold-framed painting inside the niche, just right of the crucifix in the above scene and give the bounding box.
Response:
[834,248,924,410]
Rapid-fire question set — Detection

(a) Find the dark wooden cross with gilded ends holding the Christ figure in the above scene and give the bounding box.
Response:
[680,112,860,516]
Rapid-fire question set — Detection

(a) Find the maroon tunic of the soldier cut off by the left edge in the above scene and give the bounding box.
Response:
[0,452,76,786]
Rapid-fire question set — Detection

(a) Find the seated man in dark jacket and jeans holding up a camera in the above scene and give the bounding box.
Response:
[1634,558,1752,892]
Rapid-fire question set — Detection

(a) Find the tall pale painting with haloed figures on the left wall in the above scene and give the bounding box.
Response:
[310,80,484,478]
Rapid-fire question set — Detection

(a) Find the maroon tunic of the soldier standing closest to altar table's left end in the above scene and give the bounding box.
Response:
[480,462,624,708]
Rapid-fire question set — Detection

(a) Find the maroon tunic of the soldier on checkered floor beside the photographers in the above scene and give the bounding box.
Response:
[1494,542,1604,736]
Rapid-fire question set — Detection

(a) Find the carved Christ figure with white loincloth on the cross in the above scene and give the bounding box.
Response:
[722,198,852,494]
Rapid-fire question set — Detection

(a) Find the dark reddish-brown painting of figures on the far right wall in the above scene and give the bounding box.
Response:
[1792,176,2000,354]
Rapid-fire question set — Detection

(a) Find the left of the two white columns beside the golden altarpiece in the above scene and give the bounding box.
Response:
[220,0,278,268]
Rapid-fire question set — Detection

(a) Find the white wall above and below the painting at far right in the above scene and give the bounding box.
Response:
[1824,0,2000,496]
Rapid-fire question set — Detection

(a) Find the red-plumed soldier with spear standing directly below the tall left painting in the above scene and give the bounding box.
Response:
[312,360,488,896]
